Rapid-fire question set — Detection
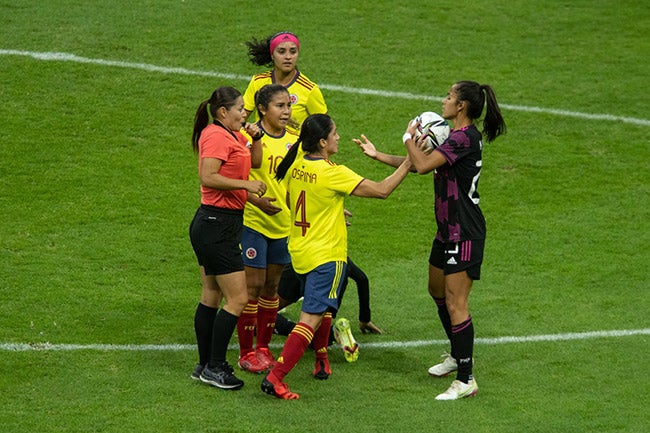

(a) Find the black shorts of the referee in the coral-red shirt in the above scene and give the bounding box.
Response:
[190,205,244,275]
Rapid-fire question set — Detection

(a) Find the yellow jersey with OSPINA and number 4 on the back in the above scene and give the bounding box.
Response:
[283,156,363,274]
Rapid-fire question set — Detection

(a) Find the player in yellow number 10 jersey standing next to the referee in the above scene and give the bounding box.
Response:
[237,84,298,373]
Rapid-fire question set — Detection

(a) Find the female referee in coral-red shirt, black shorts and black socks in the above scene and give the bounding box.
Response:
[190,87,266,390]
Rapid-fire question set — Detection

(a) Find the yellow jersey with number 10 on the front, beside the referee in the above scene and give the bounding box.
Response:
[244,131,298,239]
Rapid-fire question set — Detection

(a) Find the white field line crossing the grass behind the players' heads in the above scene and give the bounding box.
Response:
[0,49,650,126]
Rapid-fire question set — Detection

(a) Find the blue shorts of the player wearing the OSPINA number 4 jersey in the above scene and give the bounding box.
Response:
[297,262,347,314]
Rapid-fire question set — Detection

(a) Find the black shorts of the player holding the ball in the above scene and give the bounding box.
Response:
[429,239,485,280]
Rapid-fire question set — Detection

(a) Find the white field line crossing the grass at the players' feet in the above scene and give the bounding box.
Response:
[0,328,650,352]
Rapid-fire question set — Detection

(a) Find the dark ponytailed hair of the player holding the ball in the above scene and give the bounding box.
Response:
[454,81,506,142]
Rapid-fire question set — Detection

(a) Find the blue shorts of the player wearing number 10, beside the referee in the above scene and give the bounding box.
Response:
[241,226,291,269]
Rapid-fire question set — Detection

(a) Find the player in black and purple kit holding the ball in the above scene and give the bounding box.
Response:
[355,81,506,400]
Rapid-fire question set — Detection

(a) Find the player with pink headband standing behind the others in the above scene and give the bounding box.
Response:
[244,31,327,134]
